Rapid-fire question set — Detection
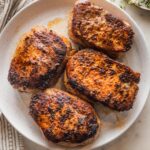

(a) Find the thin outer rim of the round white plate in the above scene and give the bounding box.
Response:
[0,0,150,149]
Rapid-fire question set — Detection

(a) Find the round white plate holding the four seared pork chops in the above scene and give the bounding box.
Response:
[0,0,150,150]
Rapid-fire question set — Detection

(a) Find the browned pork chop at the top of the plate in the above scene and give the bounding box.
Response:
[69,1,134,57]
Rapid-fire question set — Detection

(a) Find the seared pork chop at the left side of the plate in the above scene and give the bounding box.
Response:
[8,26,71,92]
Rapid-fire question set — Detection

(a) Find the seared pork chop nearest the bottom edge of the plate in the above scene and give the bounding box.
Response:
[30,89,100,146]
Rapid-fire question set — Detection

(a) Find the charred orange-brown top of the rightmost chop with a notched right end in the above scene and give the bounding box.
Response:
[65,49,140,111]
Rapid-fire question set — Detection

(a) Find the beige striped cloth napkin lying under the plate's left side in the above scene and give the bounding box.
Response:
[0,0,33,150]
